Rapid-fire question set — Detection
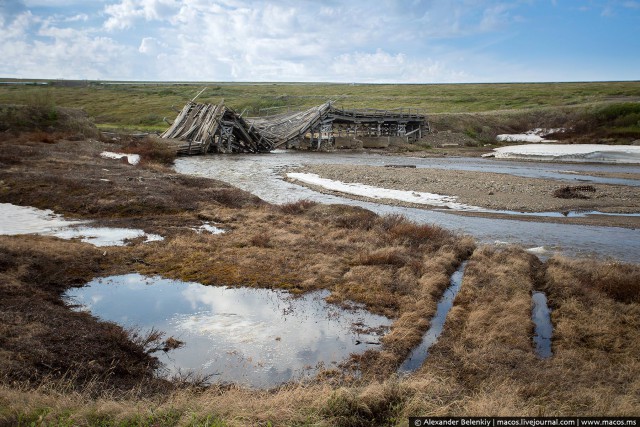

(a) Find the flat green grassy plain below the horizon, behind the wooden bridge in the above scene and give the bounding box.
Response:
[0,82,640,130]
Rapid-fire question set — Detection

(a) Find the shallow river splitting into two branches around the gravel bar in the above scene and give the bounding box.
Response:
[175,150,640,262]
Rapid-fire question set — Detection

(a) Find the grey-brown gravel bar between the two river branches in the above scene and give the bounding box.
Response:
[292,165,640,228]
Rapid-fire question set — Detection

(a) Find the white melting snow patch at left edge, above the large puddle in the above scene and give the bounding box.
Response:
[0,203,163,246]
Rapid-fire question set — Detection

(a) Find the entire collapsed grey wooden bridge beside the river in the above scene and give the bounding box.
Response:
[161,101,429,155]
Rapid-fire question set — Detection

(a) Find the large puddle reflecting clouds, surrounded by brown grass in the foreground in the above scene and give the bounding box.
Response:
[65,274,391,387]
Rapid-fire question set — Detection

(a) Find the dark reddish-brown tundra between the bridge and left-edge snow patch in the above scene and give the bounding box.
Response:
[0,140,264,218]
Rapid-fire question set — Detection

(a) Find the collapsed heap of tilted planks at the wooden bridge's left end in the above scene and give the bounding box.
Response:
[160,101,274,155]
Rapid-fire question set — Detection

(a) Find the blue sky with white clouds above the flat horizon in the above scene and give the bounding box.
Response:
[0,0,640,83]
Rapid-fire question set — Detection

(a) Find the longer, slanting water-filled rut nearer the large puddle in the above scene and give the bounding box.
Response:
[398,261,467,373]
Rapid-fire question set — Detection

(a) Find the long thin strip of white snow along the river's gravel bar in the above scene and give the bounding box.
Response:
[287,172,486,211]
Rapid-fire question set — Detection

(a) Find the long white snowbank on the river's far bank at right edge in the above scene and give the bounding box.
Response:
[484,144,640,163]
